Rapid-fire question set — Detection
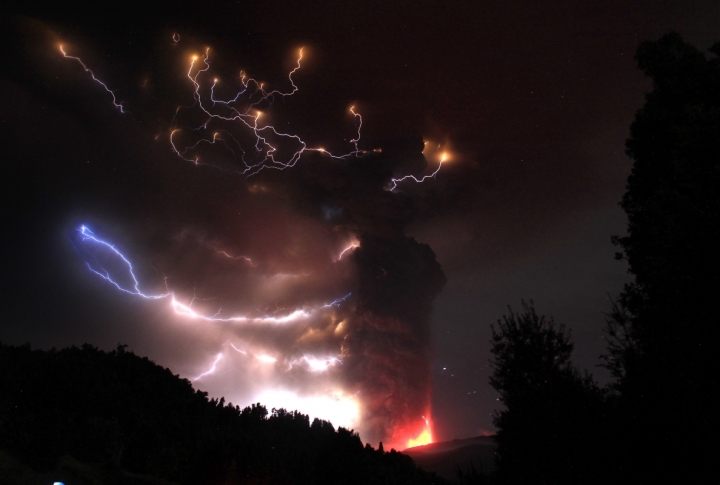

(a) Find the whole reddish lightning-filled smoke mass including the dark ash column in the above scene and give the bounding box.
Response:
[67,35,445,448]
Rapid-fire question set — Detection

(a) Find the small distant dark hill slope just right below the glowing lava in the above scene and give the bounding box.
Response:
[403,436,496,480]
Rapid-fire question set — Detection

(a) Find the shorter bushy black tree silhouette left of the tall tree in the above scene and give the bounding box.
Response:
[490,302,608,484]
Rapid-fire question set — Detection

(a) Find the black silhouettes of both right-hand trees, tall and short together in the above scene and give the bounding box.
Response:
[491,33,720,485]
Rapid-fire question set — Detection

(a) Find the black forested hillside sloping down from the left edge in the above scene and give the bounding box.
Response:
[0,344,445,485]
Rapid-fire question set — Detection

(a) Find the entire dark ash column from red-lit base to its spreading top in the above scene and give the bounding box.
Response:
[270,137,446,446]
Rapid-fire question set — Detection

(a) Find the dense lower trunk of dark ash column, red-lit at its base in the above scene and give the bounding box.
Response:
[348,234,445,443]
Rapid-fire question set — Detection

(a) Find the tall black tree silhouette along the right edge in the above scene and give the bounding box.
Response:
[608,33,720,483]
